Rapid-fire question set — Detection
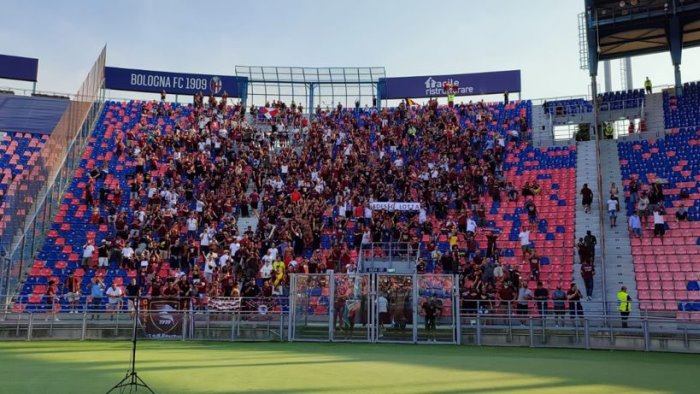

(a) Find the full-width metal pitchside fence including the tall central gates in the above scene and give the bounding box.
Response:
[0,294,700,353]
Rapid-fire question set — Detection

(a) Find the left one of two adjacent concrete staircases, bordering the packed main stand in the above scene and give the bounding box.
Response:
[573,141,608,316]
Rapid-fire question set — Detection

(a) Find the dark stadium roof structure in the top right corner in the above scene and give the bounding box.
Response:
[585,0,700,92]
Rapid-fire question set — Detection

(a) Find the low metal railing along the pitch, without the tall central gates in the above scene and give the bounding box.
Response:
[0,297,700,352]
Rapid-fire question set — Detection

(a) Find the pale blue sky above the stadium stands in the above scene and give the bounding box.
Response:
[0,0,700,99]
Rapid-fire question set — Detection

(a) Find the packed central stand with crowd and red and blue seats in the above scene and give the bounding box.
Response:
[15,97,576,320]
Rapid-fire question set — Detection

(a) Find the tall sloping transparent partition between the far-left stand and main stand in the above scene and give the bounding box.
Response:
[0,48,106,304]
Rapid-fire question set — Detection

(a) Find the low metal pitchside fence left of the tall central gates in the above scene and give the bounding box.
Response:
[0,297,289,341]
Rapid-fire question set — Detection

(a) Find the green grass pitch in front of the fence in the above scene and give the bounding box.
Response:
[0,341,700,394]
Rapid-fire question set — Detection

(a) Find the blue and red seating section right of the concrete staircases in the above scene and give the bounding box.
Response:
[618,127,700,320]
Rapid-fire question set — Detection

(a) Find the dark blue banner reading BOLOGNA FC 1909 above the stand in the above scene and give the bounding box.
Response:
[105,67,248,97]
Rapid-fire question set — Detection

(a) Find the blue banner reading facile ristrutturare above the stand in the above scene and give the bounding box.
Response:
[379,70,520,99]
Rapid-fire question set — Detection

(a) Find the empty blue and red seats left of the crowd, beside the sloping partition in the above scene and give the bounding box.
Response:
[15,101,196,310]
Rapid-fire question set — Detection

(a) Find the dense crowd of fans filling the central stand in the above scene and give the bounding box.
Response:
[35,94,592,322]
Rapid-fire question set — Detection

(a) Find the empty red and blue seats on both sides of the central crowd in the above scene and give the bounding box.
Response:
[17,101,576,320]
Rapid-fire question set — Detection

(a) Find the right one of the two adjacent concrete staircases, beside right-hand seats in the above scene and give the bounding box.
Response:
[598,140,639,316]
